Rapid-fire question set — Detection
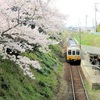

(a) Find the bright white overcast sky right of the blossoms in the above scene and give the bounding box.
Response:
[54,0,100,27]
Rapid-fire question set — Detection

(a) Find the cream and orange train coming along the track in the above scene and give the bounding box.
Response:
[66,37,81,64]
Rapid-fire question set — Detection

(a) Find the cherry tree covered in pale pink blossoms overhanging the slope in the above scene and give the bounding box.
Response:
[0,0,67,79]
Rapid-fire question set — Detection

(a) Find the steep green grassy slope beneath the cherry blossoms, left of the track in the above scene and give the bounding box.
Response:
[0,38,62,100]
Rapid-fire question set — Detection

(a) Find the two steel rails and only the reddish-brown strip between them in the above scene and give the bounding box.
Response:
[70,65,89,100]
